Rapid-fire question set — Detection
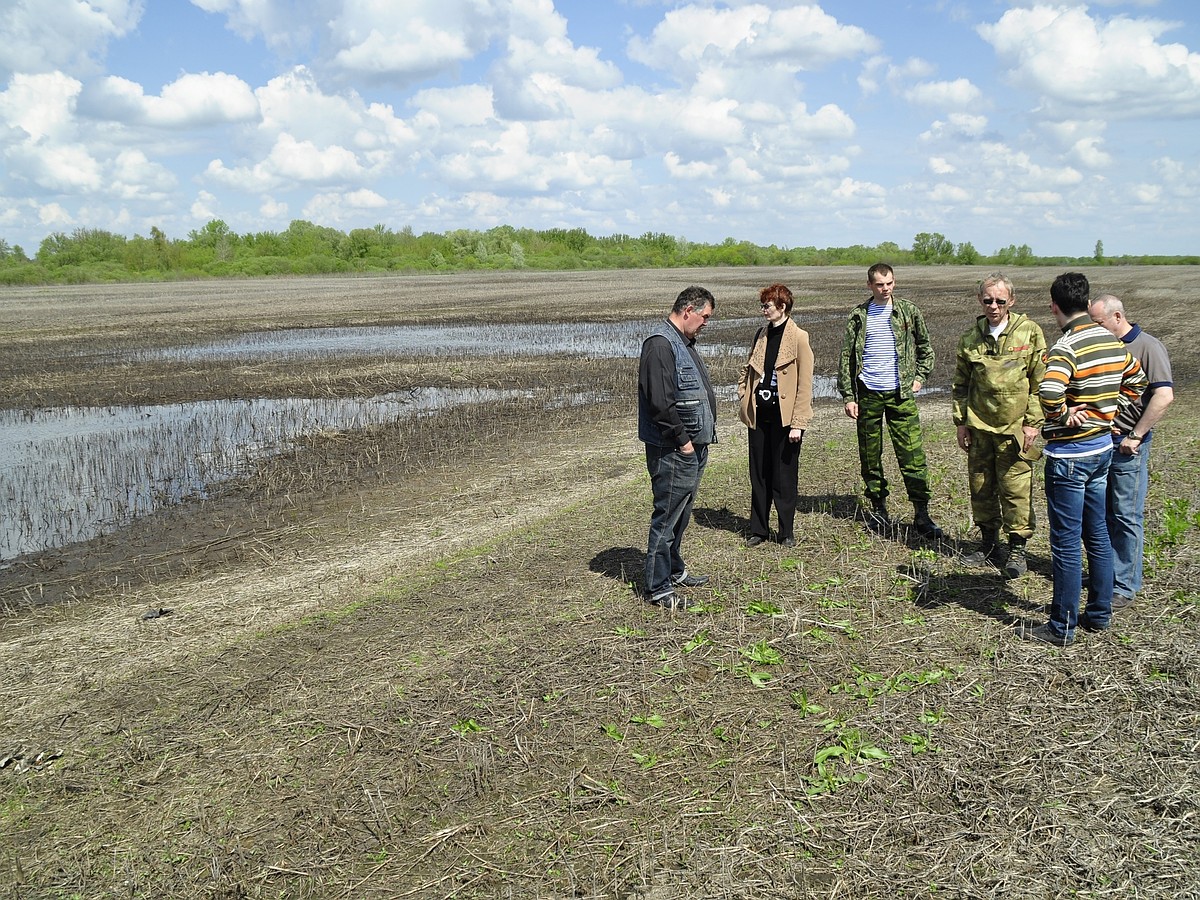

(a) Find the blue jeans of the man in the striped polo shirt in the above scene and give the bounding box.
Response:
[1045,450,1112,638]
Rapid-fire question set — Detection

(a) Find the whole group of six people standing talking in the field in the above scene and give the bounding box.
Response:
[637,263,1174,647]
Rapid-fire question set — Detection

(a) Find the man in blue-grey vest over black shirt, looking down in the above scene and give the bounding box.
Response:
[637,287,716,610]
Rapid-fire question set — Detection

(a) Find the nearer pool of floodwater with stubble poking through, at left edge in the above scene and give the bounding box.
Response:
[0,388,525,562]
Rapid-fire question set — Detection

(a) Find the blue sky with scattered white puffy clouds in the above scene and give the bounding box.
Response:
[0,0,1200,257]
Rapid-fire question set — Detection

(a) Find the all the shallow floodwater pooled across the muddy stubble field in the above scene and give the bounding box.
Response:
[0,301,835,566]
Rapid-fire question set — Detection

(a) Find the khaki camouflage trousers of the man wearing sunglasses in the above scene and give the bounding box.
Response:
[967,428,1037,540]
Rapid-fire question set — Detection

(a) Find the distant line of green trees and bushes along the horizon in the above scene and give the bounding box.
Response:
[0,218,1200,284]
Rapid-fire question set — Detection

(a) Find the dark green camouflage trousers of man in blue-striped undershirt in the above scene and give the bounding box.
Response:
[858,385,932,503]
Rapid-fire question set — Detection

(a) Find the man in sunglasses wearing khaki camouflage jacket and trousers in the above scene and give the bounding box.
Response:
[952,272,1046,578]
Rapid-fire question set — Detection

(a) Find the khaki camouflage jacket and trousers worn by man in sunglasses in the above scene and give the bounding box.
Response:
[952,311,1046,542]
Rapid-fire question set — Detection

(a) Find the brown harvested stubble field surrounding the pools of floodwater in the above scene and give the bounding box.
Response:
[0,268,1200,900]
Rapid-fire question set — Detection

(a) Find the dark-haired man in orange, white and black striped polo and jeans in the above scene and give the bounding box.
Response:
[1019,272,1146,647]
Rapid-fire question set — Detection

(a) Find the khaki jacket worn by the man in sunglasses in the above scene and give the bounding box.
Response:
[950,312,1046,434]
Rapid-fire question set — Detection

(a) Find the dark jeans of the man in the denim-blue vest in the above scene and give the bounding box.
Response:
[646,444,708,600]
